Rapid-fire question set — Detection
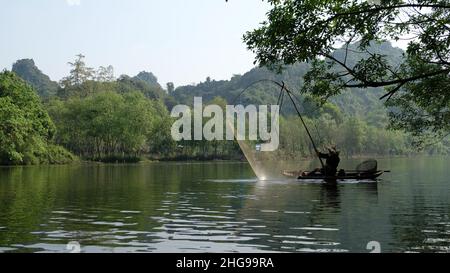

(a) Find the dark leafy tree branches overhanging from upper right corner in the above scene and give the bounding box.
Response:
[244,0,450,144]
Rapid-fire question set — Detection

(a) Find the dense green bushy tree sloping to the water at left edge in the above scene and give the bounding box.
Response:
[0,71,73,165]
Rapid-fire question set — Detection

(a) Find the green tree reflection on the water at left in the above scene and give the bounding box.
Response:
[0,164,192,247]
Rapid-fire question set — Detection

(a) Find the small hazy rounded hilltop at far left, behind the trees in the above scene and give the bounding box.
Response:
[12,59,59,98]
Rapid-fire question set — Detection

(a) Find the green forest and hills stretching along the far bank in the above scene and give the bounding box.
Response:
[0,42,450,164]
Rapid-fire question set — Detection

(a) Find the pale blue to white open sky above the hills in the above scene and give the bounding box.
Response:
[0,0,269,86]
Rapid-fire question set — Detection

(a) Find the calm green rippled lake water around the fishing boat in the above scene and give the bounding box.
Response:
[0,158,450,252]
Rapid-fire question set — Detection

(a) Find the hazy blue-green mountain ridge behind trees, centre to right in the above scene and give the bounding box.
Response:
[172,39,404,126]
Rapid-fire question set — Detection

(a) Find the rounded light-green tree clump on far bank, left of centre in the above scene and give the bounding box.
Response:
[48,91,174,160]
